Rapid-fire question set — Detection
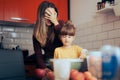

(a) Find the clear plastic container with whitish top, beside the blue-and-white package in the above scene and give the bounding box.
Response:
[87,51,102,78]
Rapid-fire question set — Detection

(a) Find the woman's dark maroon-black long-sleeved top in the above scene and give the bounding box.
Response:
[33,21,64,69]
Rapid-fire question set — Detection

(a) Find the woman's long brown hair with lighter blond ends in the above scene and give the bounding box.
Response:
[34,1,58,46]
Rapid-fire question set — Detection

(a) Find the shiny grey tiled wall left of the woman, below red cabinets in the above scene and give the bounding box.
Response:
[0,26,34,55]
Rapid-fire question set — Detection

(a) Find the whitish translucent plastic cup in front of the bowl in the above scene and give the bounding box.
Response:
[53,59,70,80]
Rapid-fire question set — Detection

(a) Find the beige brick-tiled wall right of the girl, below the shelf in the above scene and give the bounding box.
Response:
[74,10,120,50]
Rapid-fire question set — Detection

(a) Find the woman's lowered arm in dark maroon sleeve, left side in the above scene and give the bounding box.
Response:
[33,36,46,69]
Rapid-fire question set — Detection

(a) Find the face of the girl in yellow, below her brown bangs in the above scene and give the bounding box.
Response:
[60,35,75,47]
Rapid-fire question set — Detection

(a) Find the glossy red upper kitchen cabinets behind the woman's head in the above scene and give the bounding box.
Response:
[0,0,68,23]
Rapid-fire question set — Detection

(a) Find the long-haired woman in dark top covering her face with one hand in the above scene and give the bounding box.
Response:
[33,1,64,77]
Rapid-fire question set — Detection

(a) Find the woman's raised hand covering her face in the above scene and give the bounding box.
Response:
[45,8,58,25]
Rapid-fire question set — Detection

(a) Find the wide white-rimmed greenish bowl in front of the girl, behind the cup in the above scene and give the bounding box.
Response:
[50,59,83,70]
